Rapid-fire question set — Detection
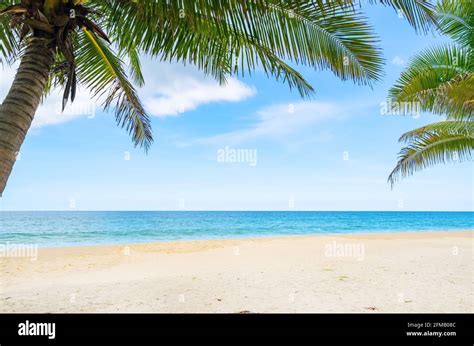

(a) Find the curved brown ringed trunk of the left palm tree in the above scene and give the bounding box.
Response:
[0,38,53,196]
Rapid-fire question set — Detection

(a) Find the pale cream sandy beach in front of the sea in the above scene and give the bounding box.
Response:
[0,230,474,313]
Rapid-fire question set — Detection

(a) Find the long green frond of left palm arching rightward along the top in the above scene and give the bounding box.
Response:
[93,0,383,94]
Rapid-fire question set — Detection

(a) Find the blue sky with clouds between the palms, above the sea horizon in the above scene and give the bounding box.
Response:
[0,6,474,210]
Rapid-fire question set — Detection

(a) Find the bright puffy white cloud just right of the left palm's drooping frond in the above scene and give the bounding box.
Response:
[140,60,256,118]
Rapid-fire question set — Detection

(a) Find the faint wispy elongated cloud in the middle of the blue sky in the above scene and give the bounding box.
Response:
[194,101,344,144]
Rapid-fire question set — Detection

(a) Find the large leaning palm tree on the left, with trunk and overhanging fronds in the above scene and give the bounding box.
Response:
[0,0,434,195]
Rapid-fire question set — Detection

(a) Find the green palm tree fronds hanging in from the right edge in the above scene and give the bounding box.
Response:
[388,0,474,187]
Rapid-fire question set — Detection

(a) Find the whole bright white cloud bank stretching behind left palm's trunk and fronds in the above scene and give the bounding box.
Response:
[0,58,256,128]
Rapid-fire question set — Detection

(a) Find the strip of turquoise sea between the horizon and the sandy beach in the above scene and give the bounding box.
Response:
[0,211,474,246]
